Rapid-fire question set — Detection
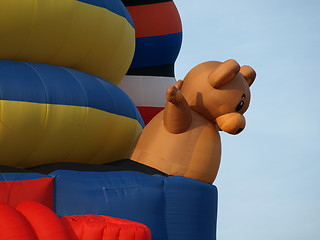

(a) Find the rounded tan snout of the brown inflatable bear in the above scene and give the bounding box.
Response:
[216,112,246,134]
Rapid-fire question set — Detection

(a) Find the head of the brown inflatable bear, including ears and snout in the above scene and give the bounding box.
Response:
[181,59,256,134]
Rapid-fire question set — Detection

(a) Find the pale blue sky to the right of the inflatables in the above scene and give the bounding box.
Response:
[175,0,320,240]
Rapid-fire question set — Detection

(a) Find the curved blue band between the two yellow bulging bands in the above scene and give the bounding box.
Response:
[0,60,144,126]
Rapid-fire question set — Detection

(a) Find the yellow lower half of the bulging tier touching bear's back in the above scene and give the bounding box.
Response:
[0,100,142,168]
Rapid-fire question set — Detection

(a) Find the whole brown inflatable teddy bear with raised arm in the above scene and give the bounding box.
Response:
[131,59,256,183]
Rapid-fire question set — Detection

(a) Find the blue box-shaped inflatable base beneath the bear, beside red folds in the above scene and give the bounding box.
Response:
[50,170,217,240]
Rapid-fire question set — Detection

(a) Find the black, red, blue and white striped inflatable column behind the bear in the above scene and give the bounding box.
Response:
[119,0,182,123]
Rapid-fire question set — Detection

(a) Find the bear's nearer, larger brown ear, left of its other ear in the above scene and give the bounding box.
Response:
[208,59,240,88]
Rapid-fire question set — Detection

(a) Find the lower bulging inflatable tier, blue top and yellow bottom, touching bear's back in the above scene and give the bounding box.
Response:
[0,60,143,167]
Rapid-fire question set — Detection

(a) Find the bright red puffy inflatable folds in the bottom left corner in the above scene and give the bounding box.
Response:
[0,201,151,240]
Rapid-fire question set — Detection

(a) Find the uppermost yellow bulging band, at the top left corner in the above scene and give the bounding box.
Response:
[0,0,135,84]
